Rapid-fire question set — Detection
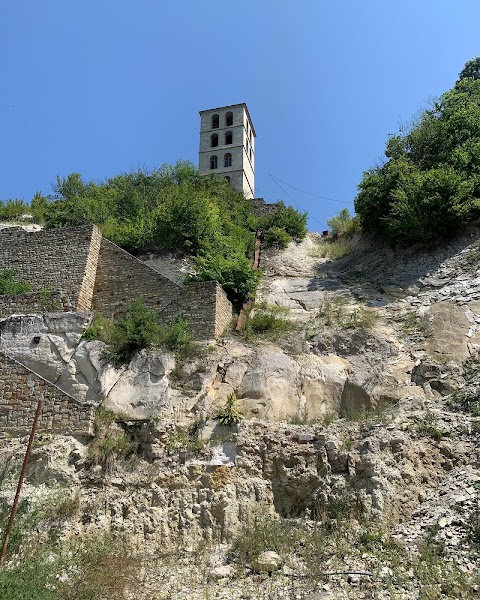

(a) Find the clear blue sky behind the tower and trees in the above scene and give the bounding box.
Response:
[0,0,480,230]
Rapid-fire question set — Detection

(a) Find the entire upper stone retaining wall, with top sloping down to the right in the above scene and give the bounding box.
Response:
[0,226,232,339]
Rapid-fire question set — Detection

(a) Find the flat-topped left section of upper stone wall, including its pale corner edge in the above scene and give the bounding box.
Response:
[0,226,101,310]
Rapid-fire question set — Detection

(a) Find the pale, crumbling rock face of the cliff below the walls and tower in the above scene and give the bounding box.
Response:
[0,233,480,599]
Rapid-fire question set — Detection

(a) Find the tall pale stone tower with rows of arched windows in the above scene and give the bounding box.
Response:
[198,103,255,198]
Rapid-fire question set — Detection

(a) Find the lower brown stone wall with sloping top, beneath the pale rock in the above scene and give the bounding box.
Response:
[0,352,95,436]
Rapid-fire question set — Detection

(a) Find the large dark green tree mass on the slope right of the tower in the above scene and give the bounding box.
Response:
[355,63,480,244]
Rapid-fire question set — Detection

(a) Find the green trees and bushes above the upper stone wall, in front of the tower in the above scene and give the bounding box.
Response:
[0,161,307,305]
